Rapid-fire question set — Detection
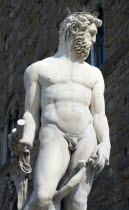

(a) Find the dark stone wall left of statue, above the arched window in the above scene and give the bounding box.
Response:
[0,0,80,166]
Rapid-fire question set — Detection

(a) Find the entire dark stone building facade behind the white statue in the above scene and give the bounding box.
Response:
[0,0,129,210]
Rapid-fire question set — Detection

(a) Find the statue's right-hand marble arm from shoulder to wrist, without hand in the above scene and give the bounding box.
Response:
[91,71,110,146]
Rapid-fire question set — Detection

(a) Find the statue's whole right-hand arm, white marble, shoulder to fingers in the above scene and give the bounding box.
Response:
[89,69,111,172]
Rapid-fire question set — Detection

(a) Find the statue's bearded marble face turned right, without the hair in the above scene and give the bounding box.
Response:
[71,23,97,60]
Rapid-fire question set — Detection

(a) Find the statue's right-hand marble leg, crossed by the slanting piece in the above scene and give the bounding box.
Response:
[63,125,97,210]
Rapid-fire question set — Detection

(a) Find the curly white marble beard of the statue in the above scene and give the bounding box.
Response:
[74,32,92,60]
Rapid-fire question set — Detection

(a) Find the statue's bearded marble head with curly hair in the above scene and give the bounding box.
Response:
[59,12,102,60]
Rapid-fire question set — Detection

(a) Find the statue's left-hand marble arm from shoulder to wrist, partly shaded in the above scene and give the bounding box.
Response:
[20,64,40,147]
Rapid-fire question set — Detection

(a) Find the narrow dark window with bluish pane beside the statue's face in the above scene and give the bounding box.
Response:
[86,7,106,67]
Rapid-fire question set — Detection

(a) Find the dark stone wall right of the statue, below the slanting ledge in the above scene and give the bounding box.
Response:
[89,49,129,210]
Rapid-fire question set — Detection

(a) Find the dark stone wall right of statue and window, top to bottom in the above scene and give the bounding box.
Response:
[88,0,129,210]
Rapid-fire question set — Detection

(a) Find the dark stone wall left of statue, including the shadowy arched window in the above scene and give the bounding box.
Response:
[0,0,81,210]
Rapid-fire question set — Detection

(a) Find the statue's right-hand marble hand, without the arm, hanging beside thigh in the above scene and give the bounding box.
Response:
[88,142,110,174]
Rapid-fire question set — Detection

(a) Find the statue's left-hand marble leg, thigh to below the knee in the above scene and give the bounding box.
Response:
[24,127,70,210]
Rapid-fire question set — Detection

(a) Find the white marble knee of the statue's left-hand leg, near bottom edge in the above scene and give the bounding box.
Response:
[36,190,52,208]
